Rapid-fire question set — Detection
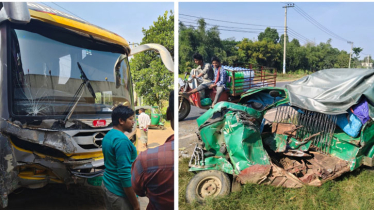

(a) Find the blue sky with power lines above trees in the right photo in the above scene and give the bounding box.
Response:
[179,2,374,59]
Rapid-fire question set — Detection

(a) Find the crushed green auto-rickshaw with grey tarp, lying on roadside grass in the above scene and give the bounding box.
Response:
[186,69,374,201]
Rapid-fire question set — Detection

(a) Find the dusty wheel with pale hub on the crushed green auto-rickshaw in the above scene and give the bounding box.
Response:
[186,170,231,203]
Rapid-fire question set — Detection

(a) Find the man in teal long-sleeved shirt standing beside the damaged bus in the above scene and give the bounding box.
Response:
[101,105,140,210]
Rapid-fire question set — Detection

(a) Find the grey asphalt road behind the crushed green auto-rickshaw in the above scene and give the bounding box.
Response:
[179,81,290,158]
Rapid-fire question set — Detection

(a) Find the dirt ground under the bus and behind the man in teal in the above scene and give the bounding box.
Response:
[0,128,174,210]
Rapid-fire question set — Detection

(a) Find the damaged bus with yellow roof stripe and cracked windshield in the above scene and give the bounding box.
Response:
[0,2,172,207]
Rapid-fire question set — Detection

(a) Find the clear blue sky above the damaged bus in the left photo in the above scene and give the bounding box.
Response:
[39,2,174,43]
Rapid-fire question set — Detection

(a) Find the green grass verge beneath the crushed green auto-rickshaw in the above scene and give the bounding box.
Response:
[179,159,374,210]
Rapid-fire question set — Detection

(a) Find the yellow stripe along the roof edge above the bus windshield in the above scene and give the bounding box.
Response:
[29,10,130,49]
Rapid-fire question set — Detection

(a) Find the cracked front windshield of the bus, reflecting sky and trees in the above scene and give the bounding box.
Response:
[9,26,132,116]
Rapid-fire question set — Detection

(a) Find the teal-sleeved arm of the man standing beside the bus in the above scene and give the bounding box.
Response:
[114,139,140,209]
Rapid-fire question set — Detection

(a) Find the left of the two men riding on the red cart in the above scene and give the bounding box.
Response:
[183,53,214,97]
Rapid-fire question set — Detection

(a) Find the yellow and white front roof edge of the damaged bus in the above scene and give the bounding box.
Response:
[27,2,130,52]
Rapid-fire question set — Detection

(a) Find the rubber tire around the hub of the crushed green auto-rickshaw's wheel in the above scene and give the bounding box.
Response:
[186,170,231,203]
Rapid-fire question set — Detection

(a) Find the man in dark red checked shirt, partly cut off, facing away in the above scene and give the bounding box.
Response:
[131,91,174,210]
